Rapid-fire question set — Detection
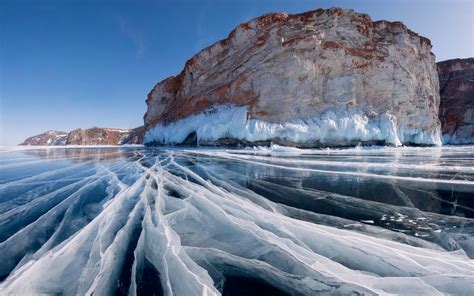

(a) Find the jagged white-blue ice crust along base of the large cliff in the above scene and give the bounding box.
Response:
[144,105,441,146]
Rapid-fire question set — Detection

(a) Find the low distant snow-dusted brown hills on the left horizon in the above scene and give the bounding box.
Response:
[20,126,144,146]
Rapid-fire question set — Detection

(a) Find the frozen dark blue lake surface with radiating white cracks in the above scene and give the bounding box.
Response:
[0,146,474,295]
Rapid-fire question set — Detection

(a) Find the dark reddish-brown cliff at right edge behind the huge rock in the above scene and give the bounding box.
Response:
[437,58,474,144]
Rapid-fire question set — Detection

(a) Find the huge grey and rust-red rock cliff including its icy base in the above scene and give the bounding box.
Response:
[144,8,440,146]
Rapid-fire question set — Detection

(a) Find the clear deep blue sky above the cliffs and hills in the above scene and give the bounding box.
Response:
[0,0,474,145]
